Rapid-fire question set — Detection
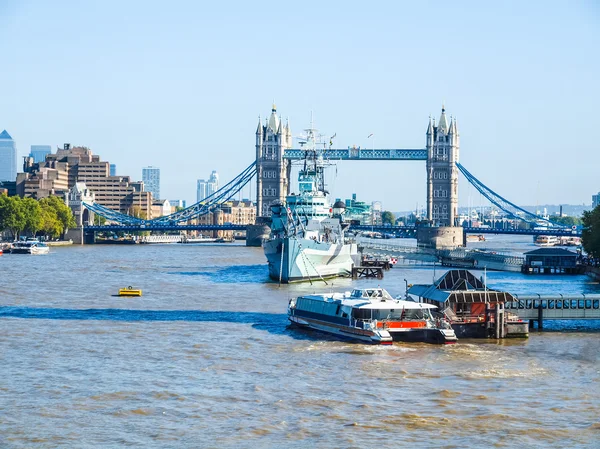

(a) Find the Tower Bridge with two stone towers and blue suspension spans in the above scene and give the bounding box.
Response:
[80,105,581,244]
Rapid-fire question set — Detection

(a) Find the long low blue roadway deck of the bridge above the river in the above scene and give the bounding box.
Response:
[84,224,581,238]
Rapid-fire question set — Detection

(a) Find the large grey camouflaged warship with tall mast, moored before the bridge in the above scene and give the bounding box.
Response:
[263,124,358,283]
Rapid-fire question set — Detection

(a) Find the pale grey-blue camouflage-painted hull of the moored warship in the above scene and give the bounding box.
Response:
[264,238,358,283]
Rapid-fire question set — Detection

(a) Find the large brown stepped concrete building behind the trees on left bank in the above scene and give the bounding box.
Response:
[16,143,152,219]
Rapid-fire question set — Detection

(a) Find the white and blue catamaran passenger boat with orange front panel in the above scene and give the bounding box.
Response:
[288,287,457,344]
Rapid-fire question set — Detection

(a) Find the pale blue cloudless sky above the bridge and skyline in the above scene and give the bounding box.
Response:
[0,0,600,211]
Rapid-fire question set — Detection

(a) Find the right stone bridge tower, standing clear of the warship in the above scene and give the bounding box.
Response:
[427,105,460,226]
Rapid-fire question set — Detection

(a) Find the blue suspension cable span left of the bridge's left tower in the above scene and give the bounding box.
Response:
[83,161,256,226]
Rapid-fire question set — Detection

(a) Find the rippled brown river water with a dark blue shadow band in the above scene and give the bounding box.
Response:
[0,238,600,448]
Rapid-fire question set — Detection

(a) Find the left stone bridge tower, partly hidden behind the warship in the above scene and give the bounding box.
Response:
[256,105,292,217]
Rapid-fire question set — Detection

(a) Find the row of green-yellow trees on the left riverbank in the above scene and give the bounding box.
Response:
[0,195,76,239]
